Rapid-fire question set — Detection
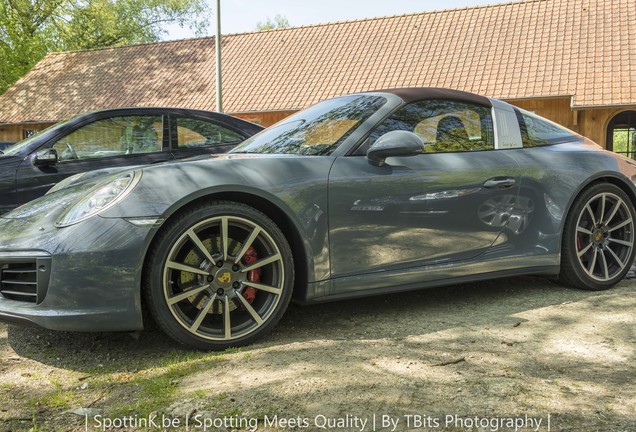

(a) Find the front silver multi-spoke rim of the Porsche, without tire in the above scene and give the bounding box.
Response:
[163,216,285,342]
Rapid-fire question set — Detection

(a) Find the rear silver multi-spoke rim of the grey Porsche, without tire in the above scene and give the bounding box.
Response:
[574,192,634,282]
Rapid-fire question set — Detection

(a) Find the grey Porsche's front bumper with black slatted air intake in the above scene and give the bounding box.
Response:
[0,216,156,331]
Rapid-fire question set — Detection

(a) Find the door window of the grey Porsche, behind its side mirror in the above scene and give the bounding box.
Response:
[369,100,495,153]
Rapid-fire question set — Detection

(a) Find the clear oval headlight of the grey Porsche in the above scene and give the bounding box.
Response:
[55,171,141,228]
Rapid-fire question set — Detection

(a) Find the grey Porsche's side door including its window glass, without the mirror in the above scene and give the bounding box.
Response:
[329,100,519,282]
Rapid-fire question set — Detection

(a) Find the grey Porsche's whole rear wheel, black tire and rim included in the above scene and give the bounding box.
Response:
[559,183,636,291]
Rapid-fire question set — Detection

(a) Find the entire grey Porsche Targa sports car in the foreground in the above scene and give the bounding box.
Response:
[0,88,636,349]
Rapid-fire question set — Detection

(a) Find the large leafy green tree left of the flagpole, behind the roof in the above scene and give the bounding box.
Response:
[0,0,209,93]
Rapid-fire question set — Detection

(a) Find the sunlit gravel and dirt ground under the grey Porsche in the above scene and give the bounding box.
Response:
[0,277,636,432]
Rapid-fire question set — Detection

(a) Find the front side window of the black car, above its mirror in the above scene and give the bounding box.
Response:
[53,115,163,162]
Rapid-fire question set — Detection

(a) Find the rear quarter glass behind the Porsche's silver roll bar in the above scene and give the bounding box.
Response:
[515,108,583,147]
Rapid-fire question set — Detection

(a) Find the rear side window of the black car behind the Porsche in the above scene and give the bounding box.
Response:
[171,116,245,148]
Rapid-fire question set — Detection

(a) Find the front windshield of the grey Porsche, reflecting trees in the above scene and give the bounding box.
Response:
[230,95,386,156]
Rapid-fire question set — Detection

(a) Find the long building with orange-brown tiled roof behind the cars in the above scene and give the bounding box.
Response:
[0,0,636,152]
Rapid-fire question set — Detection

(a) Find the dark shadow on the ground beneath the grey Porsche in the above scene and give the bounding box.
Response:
[0,277,598,371]
